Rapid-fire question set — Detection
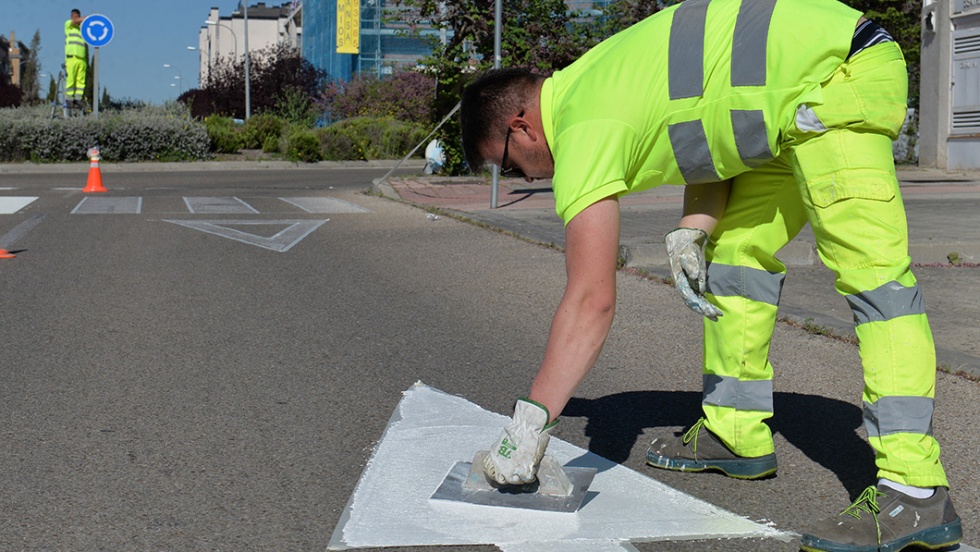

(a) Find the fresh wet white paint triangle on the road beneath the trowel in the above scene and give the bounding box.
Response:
[328,383,790,552]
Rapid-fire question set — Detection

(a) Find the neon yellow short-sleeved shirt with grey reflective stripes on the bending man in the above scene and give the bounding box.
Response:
[541,0,861,224]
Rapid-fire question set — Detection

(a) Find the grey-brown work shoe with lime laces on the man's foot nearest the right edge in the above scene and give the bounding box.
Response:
[800,485,963,552]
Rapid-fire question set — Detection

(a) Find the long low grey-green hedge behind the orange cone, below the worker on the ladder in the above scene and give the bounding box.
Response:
[0,104,211,163]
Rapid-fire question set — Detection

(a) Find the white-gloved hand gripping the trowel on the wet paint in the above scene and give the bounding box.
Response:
[483,399,558,485]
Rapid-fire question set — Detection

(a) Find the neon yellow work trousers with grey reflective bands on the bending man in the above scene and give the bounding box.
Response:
[702,43,947,487]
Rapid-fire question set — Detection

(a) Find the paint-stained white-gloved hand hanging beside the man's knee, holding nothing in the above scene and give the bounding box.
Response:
[664,228,721,320]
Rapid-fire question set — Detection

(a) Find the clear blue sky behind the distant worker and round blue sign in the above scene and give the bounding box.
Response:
[0,0,253,104]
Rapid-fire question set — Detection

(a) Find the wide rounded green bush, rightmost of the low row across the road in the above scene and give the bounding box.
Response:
[317,117,426,161]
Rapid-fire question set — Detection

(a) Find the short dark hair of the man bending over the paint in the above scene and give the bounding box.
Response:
[459,68,545,172]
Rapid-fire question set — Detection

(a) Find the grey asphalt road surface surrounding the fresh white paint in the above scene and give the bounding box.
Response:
[0,168,980,551]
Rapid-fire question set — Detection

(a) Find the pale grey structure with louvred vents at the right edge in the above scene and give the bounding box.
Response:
[919,0,980,170]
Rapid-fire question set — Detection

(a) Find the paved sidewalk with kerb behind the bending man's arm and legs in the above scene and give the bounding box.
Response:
[374,167,980,378]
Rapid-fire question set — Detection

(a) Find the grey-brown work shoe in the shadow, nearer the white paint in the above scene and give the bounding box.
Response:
[647,418,776,479]
